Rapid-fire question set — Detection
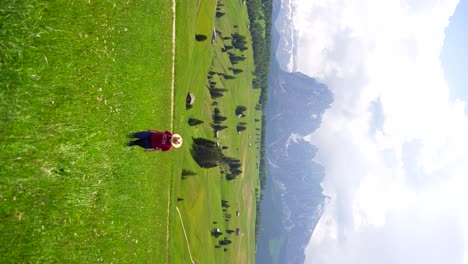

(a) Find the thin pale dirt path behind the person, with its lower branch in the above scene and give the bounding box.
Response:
[166,0,177,263]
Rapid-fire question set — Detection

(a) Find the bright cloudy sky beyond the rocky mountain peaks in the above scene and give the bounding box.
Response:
[280,0,468,264]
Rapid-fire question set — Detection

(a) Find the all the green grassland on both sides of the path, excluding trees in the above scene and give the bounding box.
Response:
[0,0,260,263]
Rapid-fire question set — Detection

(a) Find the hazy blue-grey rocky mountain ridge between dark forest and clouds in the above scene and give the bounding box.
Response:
[256,0,333,264]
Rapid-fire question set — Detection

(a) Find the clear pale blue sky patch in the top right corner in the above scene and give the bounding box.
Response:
[440,0,468,109]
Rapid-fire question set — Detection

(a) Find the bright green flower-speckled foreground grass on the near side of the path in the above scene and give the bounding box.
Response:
[0,0,173,263]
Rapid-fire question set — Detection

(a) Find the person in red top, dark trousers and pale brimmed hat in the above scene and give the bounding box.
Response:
[127,129,183,151]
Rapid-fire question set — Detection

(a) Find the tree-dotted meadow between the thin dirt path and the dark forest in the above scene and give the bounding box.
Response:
[170,0,261,263]
